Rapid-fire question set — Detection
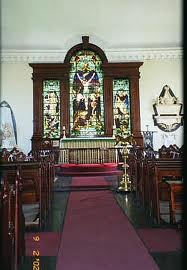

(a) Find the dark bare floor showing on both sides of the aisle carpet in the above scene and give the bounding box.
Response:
[20,175,183,270]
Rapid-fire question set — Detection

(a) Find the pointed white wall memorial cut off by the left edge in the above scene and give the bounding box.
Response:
[0,100,17,149]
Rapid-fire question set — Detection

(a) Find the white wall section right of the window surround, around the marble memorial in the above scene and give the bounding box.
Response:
[140,59,183,150]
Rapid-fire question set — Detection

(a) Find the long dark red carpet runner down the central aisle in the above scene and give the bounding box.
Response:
[56,185,159,270]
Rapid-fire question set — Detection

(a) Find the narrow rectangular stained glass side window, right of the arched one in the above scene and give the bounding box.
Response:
[113,79,131,136]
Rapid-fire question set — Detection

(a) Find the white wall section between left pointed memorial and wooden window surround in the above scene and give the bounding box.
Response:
[1,63,33,153]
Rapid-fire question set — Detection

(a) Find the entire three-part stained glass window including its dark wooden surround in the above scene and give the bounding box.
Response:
[29,36,143,149]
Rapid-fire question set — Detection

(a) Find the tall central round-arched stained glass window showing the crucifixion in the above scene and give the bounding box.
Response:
[70,50,105,137]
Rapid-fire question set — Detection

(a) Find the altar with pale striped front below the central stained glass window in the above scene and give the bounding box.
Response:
[59,137,118,164]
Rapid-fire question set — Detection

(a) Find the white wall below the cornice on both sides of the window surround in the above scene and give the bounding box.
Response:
[1,59,183,153]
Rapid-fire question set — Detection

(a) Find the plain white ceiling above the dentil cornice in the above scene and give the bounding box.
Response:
[1,0,182,50]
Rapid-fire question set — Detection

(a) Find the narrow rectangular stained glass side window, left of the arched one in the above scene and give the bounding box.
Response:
[43,80,60,139]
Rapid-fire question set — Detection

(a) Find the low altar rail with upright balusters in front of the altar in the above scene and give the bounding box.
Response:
[58,147,119,164]
